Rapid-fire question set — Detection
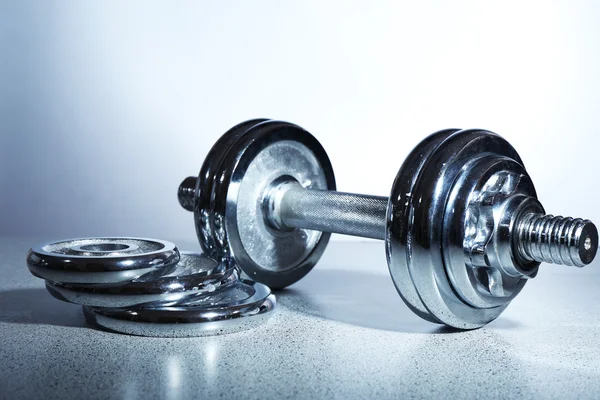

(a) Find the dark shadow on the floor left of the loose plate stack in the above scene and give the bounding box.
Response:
[0,289,87,328]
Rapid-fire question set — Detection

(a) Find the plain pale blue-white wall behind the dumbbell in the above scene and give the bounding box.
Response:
[0,1,600,240]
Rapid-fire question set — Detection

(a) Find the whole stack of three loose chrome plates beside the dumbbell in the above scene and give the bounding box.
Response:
[27,238,275,337]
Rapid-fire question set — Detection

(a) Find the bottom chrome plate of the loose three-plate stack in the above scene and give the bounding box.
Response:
[83,281,276,337]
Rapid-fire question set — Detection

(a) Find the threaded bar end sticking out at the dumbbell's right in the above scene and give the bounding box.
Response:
[517,213,598,267]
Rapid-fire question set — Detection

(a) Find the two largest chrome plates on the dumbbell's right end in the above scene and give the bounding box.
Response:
[386,130,522,329]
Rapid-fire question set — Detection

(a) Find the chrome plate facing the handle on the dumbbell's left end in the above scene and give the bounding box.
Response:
[210,121,335,288]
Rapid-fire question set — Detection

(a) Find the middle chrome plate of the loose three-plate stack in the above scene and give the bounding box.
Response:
[46,252,238,308]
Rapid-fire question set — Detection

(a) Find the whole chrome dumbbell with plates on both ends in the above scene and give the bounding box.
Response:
[178,119,598,329]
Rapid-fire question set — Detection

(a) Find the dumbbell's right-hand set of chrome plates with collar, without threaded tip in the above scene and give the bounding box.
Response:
[387,130,596,329]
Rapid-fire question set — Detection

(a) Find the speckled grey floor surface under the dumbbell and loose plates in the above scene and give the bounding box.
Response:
[0,238,600,399]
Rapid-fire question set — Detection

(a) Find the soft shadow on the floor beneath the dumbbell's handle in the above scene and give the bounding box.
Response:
[276,267,518,333]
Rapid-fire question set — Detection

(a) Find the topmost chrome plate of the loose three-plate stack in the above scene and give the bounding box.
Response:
[27,238,179,284]
